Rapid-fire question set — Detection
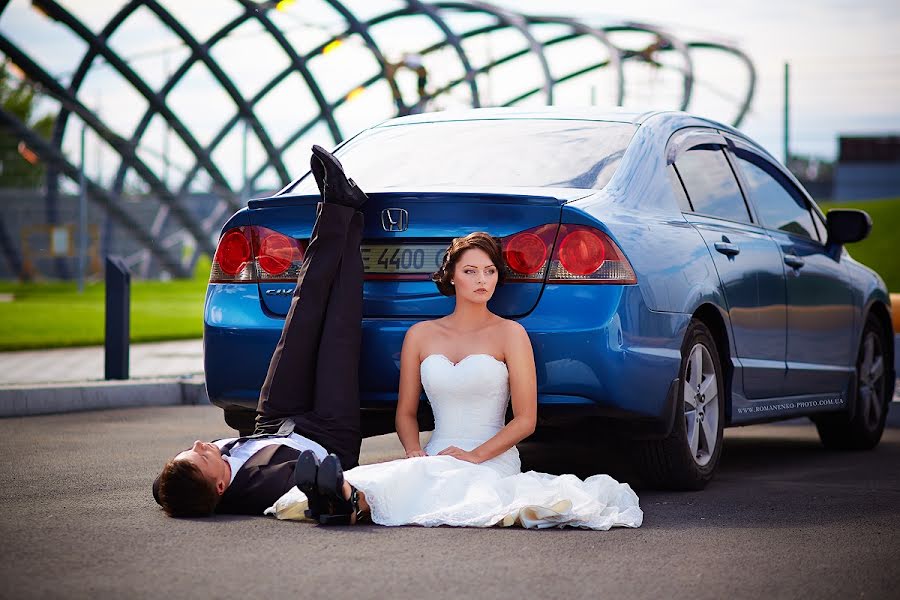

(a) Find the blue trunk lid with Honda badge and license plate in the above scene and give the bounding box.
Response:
[250,188,590,318]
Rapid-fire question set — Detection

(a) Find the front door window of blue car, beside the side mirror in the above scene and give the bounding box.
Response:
[737,152,819,240]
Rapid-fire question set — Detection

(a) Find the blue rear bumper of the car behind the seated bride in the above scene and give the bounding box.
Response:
[204,284,690,431]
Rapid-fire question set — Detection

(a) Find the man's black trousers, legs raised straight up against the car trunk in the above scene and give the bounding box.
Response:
[256,202,363,468]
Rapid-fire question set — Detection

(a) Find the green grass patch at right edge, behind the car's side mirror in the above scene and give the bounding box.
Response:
[819,198,900,293]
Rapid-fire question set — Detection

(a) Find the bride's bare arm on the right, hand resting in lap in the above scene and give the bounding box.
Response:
[438,321,537,463]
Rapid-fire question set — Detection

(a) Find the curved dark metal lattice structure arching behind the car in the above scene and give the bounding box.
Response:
[0,0,756,282]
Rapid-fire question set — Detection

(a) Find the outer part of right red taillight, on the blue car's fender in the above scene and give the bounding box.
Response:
[547,223,637,284]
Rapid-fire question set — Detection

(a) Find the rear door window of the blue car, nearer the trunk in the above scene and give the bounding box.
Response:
[675,144,752,223]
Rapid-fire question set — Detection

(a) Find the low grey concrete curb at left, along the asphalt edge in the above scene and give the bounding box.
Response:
[0,376,209,418]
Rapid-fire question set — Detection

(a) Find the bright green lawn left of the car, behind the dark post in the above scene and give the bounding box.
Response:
[0,260,209,350]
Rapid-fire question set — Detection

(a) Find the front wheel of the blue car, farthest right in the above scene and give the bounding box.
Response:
[813,314,891,450]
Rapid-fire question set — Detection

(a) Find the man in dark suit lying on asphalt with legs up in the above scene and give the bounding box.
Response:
[153,146,366,517]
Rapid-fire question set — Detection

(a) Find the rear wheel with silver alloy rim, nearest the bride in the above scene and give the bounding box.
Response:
[637,319,725,490]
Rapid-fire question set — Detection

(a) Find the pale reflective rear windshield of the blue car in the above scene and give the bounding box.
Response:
[286,119,637,193]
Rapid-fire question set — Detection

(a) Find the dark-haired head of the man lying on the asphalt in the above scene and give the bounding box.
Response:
[153,440,231,517]
